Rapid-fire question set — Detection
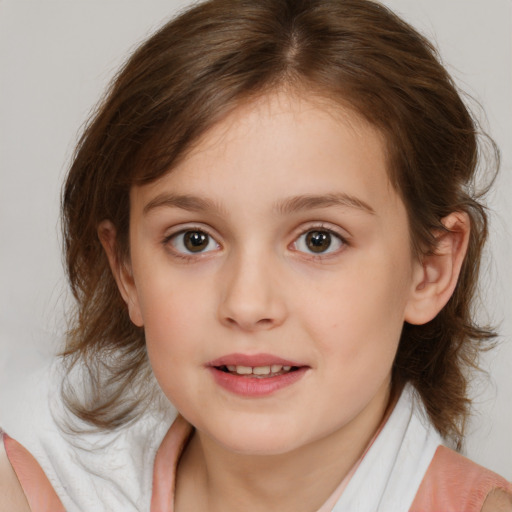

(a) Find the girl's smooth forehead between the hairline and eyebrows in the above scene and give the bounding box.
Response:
[132,92,401,219]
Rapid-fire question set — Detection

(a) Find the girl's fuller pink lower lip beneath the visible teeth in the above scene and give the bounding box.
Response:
[209,366,308,397]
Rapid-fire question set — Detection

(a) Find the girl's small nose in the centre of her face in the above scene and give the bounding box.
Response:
[219,251,287,331]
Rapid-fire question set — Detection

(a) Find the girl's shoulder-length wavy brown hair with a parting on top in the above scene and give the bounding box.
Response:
[62,0,493,442]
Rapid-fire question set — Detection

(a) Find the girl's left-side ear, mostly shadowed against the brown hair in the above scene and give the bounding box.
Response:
[98,220,144,327]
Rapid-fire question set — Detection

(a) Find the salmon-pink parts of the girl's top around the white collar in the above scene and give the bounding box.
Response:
[3,416,512,512]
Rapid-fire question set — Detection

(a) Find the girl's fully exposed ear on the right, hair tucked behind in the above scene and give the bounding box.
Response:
[405,212,470,325]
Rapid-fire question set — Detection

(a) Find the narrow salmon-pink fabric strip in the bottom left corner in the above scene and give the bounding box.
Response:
[1,433,66,512]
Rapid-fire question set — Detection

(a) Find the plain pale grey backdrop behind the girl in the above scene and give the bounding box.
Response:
[0,0,512,480]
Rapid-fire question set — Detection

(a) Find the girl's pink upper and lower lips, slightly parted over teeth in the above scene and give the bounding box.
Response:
[206,354,310,398]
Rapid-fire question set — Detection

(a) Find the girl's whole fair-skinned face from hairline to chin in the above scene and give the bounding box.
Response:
[125,94,421,453]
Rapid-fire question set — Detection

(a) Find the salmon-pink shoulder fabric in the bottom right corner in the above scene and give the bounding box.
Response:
[410,446,512,512]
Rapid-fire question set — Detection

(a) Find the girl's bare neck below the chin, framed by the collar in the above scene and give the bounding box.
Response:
[175,386,391,512]
